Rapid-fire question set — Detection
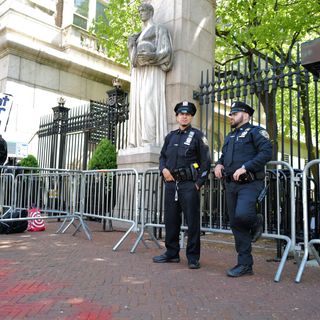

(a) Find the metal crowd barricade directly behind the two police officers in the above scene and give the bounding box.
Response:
[132,161,295,282]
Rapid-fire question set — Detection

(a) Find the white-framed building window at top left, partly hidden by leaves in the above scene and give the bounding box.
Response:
[73,0,108,30]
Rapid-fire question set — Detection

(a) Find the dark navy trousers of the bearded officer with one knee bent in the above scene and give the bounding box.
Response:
[226,180,263,266]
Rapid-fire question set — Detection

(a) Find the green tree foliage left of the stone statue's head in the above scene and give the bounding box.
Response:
[91,0,141,65]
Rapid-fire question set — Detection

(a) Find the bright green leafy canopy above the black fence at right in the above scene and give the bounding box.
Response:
[216,0,320,64]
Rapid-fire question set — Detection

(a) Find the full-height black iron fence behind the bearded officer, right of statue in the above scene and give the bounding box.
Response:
[198,45,320,258]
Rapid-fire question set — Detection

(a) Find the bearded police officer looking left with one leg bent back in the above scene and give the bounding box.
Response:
[214,101,272,277]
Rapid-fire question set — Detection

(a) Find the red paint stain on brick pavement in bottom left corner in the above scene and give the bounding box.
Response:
[0,260,113,320]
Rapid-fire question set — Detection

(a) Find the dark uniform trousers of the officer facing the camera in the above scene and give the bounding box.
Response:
[164,181,200,261]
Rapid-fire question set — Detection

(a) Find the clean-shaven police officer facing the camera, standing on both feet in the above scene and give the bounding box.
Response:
[153,101,211,269]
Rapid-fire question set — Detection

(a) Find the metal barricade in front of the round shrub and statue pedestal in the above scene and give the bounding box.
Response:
[79,169,139,251]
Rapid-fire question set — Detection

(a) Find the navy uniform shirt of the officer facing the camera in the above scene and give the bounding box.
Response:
[159,125,211,187]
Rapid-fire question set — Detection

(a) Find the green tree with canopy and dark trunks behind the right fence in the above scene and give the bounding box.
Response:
[215,0,320,162]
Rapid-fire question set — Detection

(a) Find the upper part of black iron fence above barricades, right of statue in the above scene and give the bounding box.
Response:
[198,46,320,169]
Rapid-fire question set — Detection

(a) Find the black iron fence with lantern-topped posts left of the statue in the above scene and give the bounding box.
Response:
[38,87,129,170]
